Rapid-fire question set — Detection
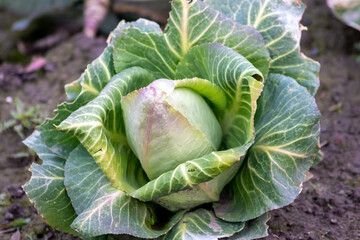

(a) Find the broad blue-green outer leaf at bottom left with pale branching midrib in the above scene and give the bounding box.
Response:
[66,145,184,238]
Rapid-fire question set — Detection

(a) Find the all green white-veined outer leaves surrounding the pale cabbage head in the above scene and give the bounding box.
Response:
[24,0,320,239]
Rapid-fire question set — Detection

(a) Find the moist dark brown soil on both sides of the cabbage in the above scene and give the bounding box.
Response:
[0,0,360,240]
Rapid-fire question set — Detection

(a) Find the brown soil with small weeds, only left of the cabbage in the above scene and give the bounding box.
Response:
[0,34,106,240]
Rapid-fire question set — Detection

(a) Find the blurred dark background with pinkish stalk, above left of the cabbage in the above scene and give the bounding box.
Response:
[0,0,170,63]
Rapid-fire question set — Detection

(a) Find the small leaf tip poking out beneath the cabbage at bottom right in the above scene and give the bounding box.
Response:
[228,213,270,240]
